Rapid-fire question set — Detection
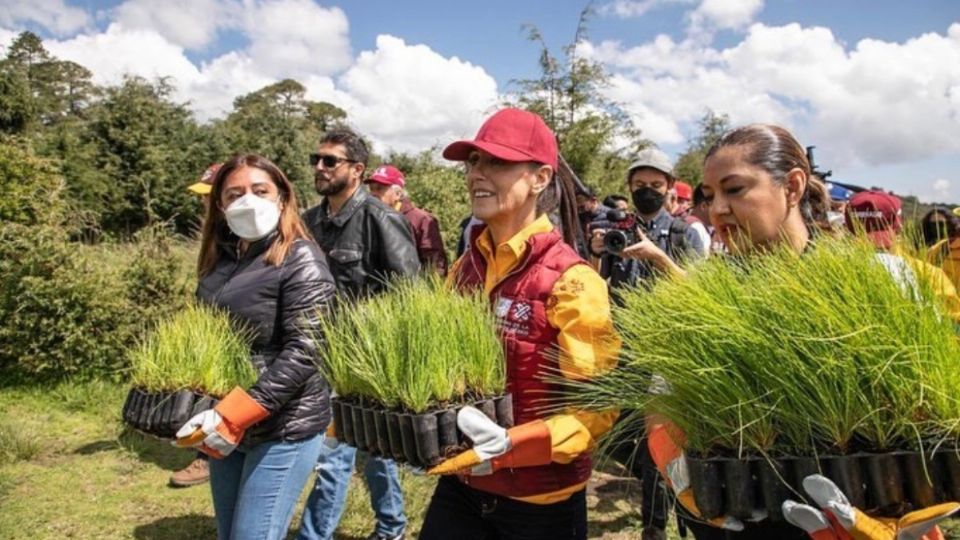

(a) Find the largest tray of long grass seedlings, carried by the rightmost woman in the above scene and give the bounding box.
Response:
[567,238,960,520]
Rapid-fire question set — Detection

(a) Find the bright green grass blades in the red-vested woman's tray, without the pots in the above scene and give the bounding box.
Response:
[320,277,506,413]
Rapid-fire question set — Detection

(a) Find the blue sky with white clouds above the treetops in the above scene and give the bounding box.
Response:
[0,0,960,202]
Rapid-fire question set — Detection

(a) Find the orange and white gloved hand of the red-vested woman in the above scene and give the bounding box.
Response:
[427,406,552,475]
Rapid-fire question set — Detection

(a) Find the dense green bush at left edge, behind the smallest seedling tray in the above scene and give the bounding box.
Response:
[0,144,192,380]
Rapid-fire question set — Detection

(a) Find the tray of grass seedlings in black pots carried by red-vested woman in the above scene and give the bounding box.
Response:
[319,278,513,467]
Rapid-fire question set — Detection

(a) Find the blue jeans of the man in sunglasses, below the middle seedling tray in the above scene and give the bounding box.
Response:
[297,444,407,540]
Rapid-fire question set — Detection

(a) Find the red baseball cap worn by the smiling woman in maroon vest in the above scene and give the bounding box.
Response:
[443,109,557,171]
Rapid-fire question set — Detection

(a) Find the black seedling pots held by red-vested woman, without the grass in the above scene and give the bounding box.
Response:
[331,394,513,468]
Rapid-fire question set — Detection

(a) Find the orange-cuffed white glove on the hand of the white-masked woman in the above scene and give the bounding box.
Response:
[173,386,270,459]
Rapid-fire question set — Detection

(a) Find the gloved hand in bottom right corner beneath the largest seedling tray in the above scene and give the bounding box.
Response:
[783,474,960,540]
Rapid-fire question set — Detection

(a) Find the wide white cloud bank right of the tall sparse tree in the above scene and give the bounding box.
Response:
[582,23,960,167]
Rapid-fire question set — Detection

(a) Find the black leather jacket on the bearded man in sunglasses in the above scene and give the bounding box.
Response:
[303,187,420,298]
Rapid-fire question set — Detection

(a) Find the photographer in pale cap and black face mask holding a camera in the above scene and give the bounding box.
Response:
[590,148,704,540]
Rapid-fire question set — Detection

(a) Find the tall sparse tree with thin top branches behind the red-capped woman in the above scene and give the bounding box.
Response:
[515,5,650,198]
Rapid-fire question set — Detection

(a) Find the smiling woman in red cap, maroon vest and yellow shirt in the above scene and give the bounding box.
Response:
[420,109,620,540]
